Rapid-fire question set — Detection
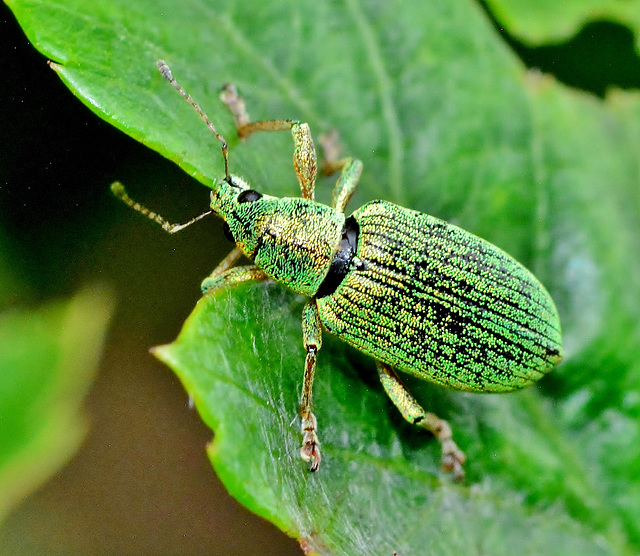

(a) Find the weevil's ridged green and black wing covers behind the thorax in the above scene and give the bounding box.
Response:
[317,201,562,392]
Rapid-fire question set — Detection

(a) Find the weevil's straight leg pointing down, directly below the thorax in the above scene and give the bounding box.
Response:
[300,299,322,471]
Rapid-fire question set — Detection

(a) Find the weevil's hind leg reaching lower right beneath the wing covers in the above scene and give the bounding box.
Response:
[376,361,467,481]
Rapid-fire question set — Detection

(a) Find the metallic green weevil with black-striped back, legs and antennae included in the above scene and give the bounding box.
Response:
[112,60,562,480]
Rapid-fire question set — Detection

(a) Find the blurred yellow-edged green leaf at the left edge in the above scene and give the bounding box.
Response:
[0,289,112,521]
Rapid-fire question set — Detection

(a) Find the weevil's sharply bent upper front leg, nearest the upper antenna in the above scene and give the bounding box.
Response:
[220,83,318,199]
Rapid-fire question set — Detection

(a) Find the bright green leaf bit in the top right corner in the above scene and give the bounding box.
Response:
[486,0,640,44]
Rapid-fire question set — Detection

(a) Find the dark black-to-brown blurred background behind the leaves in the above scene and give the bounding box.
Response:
[0,4,640,555]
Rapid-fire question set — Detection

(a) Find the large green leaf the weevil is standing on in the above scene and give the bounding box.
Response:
[11,0,640,555]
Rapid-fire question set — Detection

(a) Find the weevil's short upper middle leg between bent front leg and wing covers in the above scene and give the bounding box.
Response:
[320,130,362,212]
